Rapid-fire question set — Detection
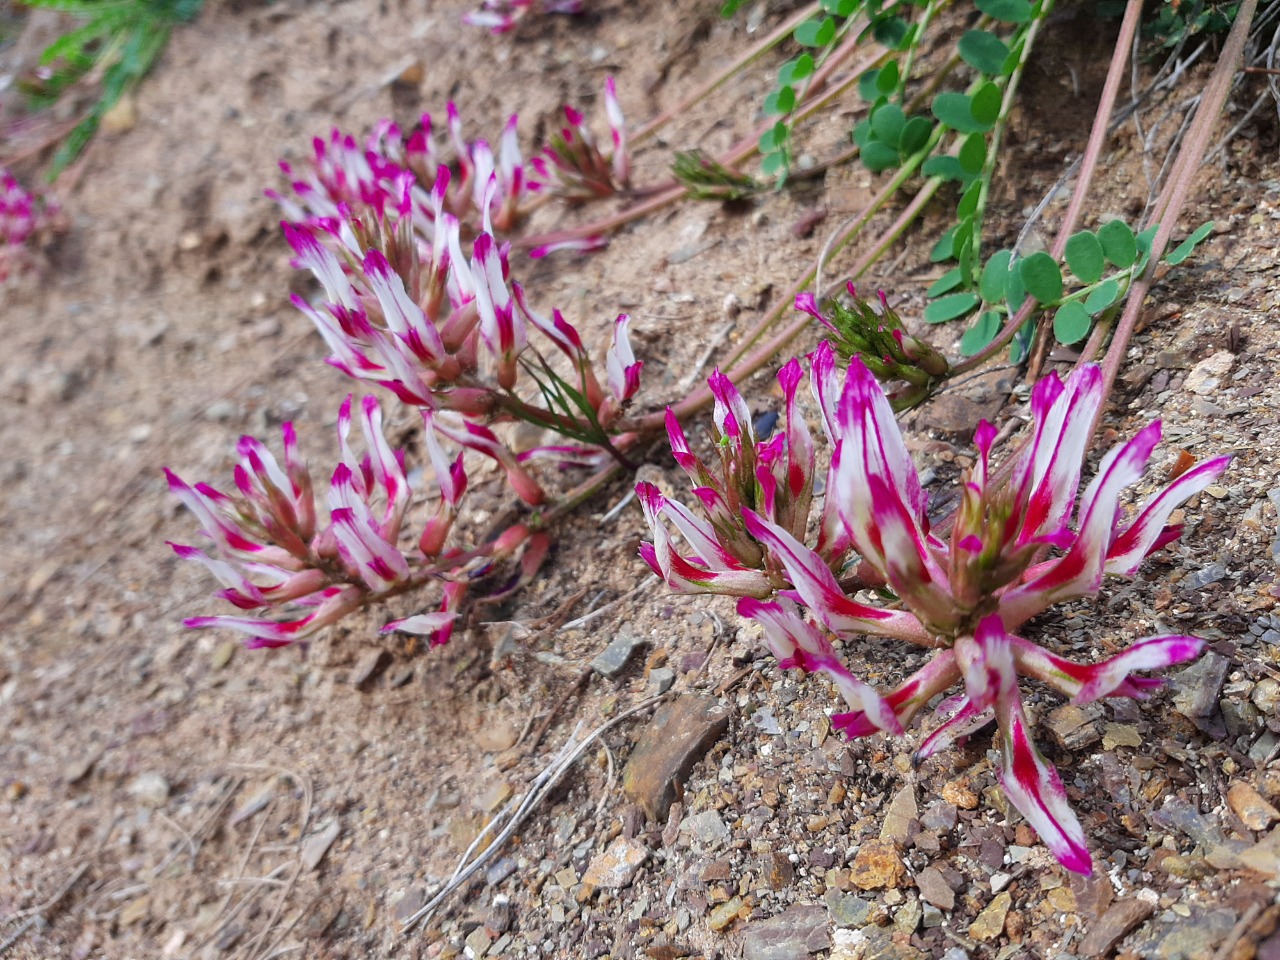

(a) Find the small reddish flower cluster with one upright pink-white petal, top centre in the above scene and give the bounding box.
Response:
[529,77,631,200]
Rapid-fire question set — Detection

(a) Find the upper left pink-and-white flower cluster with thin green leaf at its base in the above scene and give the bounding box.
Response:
[284,186,643,483]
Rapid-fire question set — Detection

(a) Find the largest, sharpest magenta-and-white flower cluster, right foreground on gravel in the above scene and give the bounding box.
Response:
[637,342,1230,873]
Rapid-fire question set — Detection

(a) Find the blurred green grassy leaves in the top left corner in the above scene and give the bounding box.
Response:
[22,0,204,179]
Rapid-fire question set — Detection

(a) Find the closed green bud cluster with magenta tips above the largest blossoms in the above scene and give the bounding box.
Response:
[796,283,950,410]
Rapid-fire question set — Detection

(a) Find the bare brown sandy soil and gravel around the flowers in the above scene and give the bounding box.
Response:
[0,0,1280,960]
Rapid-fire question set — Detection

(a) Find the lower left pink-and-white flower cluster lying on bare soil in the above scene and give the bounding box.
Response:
[165,397,545,648]
